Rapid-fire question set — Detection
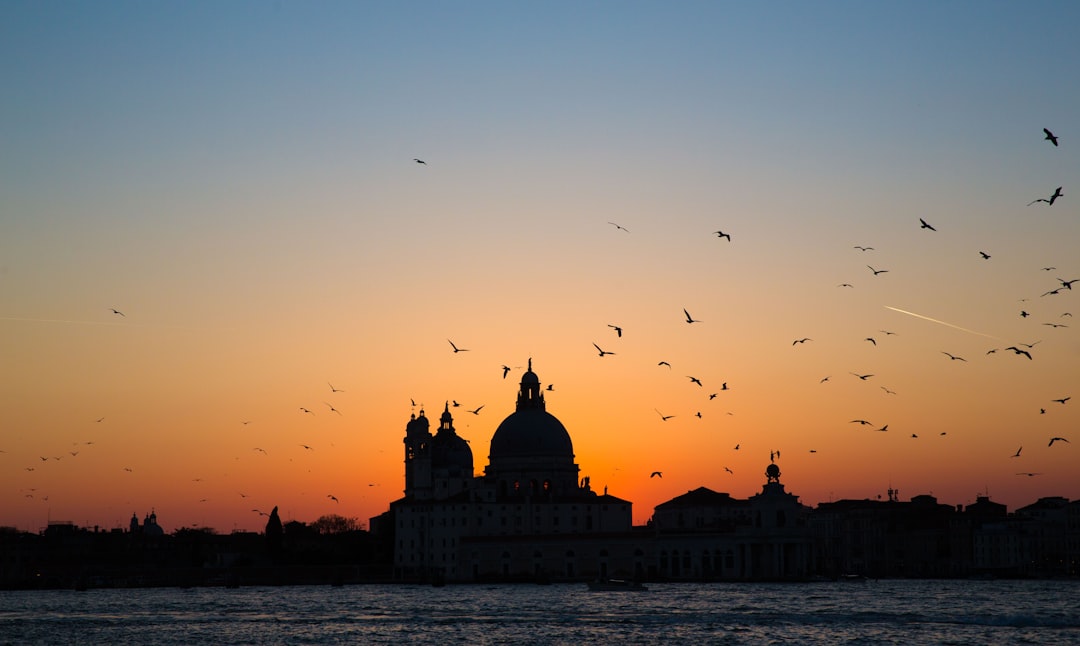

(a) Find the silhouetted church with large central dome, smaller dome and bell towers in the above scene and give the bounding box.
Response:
[373,360,645,581]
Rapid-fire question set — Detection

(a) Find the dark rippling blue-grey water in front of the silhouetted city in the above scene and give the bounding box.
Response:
[0,581,1080,645]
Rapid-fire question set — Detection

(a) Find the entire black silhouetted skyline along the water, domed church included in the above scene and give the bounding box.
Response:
[0,361,1080,589]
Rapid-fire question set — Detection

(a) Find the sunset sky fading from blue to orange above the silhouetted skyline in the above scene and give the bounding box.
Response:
[0,0,1080,531]
